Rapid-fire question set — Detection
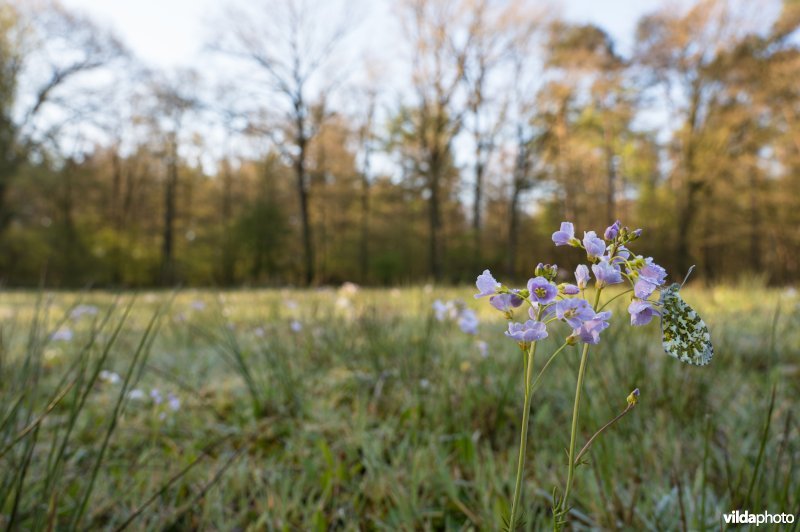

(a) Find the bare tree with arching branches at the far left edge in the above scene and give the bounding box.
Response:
[0,0,125,233]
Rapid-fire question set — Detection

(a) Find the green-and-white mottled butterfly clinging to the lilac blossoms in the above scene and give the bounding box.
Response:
[658,266,714,366]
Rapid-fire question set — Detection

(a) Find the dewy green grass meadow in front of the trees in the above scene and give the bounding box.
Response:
[0,285,800,530]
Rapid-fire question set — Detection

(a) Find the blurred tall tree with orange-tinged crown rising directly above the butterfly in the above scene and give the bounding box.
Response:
[635,0,758,274]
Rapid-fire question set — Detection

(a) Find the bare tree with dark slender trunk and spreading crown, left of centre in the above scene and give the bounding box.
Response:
[214,0,348,284]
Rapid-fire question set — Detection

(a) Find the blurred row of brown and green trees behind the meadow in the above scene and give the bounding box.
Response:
[0,0,800,287]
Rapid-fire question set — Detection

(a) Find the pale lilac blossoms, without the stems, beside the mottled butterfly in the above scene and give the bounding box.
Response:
[475,221,666,344]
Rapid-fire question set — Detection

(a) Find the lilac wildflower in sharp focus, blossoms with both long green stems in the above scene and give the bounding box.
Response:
[475,221,692,530]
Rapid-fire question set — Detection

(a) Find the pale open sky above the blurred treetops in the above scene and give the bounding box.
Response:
[62,0,663,68]
